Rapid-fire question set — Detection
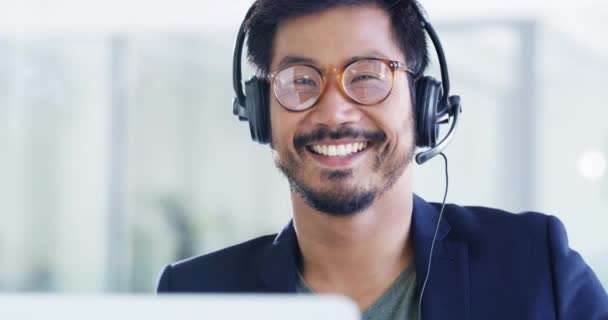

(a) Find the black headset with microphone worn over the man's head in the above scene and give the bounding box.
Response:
[232,1,462,164]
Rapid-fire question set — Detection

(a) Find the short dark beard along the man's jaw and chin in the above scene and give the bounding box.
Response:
[274,126,415,217]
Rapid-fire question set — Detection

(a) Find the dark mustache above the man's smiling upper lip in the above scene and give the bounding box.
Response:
[293,126,386,150]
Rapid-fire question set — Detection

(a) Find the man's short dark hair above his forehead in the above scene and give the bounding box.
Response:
[246,0,428,75]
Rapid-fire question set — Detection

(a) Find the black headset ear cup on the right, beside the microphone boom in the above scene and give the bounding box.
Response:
[414,77,443,148]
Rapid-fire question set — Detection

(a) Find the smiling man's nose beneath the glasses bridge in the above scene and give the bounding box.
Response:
[310,77,363,128]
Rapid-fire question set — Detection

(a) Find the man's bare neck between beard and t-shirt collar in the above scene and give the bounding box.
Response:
[292,168,413,310]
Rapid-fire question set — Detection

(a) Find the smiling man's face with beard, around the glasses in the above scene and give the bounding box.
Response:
[270,6,414,215]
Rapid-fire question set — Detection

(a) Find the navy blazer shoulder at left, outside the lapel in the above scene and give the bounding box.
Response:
[157,235,276,292]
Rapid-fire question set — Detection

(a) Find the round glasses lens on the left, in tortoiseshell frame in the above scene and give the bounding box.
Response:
[274,66,323,111]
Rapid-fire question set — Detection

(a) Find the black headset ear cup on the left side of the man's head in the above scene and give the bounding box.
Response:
[245,77,270,144]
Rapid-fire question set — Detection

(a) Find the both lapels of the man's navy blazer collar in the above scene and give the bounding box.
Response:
[260,195,470,320]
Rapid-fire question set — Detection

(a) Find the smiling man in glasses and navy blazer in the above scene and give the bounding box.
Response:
[158,0,608,319]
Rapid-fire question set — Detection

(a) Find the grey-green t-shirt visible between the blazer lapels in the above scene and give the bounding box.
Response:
[296,263,418,320]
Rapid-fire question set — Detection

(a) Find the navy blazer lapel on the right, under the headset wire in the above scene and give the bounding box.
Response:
[412,195,470,320]
